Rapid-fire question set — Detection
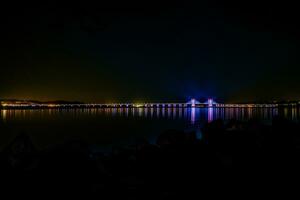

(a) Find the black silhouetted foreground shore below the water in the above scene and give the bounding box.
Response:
[0,115,300,199]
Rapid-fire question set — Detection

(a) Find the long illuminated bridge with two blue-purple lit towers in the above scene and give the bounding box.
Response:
[0,98,278,109]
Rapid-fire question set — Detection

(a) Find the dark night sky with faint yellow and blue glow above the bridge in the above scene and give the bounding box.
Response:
[0,0,300,102]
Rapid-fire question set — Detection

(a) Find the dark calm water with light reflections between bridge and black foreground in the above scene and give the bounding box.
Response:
[0,108,300,149]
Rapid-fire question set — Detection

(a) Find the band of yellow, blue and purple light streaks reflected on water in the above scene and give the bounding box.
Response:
[0,108,300,124]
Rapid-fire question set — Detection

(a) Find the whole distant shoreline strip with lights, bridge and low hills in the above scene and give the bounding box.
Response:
[0,98,300,110]
